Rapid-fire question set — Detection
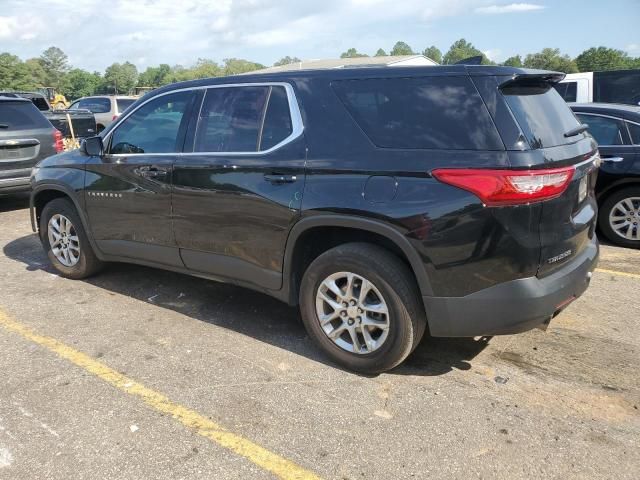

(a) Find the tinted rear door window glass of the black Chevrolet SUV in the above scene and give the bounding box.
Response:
[195,86,293,152]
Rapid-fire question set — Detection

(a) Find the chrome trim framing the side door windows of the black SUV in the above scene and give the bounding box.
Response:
[102,82,304,158]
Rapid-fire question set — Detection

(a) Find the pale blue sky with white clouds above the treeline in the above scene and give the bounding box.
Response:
[0,0,640,71]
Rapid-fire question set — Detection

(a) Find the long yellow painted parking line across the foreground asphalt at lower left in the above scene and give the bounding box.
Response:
[0,310,320,480]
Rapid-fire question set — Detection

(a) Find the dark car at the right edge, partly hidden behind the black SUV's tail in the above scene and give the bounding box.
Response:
[570,103,640,248]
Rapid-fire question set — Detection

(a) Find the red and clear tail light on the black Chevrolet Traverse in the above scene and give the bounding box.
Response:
[432,166,575,206]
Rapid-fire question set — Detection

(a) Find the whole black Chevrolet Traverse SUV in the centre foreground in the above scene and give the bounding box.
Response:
[31,65,599,372]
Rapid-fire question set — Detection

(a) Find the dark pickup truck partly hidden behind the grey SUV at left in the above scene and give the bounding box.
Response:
[0,92,98,139]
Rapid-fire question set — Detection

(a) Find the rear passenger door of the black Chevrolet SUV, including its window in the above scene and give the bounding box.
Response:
[173,84,305,290]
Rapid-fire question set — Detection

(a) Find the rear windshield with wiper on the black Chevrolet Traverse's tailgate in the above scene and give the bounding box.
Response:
[501,83,585,149]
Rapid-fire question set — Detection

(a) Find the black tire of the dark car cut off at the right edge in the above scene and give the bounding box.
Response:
[598,186,640,248]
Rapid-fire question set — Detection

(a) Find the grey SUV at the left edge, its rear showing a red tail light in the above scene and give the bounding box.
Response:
[0,95,62,194]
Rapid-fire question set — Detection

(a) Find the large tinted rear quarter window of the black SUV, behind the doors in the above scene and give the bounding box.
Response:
[332,77,504,150]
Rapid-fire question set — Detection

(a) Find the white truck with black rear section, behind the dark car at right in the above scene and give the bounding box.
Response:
[555,69,640,105]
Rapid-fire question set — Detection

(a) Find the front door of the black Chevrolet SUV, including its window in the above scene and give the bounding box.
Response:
[85,91,194,266]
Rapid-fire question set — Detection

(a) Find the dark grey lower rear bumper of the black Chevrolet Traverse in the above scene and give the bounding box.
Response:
[423,236,599,337]
